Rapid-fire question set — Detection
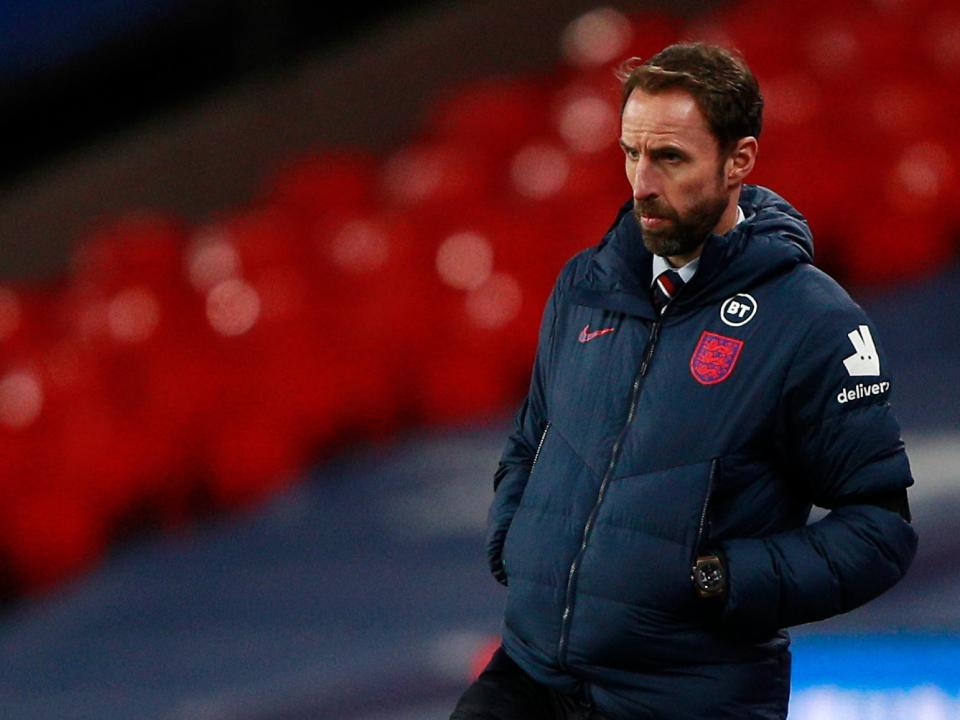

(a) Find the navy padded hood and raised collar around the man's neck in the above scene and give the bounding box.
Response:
[574,185,813,317]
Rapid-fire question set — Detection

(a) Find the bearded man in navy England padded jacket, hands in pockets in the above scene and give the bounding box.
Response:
[452,44,917,720]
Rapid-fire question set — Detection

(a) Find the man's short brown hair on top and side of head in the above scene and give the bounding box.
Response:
[618,43,763,152]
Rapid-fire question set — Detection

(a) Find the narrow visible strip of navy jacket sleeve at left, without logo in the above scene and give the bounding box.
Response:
[486,273,564,585]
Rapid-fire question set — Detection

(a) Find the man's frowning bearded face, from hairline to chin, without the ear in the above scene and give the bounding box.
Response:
[620,89,730,261]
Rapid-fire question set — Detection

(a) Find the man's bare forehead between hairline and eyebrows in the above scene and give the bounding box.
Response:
[620,89,716,147]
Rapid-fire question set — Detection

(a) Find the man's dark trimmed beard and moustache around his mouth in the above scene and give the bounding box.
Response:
[633,183,729,257]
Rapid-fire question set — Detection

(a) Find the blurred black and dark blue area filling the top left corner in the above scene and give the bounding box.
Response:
[0,0,431,185]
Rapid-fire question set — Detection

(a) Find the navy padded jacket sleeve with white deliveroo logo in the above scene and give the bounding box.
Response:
[721,302,917,633]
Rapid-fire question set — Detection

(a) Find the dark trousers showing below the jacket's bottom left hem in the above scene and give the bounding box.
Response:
[450,647,605,720]
